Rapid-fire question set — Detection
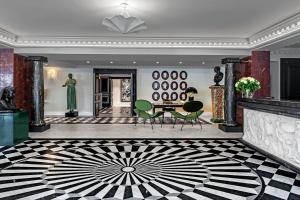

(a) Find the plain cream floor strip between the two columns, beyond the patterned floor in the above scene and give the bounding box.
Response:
[29,124,242,139]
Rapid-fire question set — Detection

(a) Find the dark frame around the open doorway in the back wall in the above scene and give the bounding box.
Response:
[93,68,137,117]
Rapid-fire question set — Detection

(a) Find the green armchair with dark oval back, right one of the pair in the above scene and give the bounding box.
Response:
[171,101,204,130]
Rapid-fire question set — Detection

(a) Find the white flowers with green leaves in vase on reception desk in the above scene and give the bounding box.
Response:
[235,77,261,98]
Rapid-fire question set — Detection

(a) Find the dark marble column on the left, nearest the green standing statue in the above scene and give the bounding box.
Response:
[27,56,50,132]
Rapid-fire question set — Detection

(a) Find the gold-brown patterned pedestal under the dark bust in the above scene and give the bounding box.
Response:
[209,85,224,123]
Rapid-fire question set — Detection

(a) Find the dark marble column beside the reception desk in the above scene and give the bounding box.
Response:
[219,58,241,132]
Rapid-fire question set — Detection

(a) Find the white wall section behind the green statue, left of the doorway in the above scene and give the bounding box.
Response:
[44,67,93,115]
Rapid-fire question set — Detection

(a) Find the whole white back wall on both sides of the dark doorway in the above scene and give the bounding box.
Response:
[44,66,224,115]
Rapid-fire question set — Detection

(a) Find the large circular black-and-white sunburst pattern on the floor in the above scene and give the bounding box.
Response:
[0,145,263,200]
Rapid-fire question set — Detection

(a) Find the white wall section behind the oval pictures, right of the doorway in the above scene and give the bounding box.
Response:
[137,67,224,112]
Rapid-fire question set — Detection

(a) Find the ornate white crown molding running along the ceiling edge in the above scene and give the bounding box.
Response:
[0,13,300,50]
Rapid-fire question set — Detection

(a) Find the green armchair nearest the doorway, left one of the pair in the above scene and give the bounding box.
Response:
[134,99,164,129]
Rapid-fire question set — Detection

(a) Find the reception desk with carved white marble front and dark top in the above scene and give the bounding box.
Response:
[238,99,300,171]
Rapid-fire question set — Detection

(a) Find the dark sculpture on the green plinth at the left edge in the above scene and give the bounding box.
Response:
[0,86,17,112]
